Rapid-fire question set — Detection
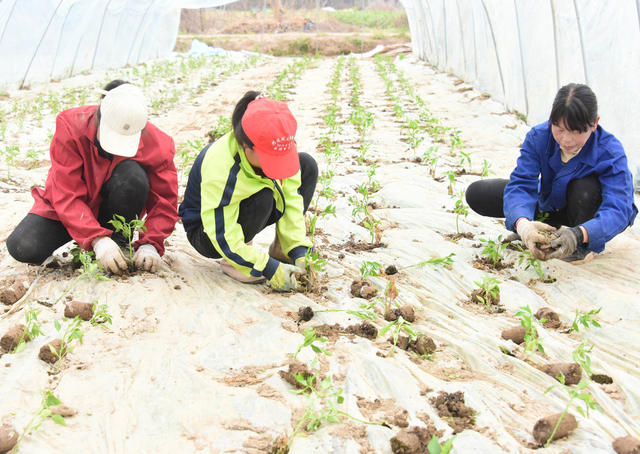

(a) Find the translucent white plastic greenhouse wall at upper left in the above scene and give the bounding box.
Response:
[0,0,234,88]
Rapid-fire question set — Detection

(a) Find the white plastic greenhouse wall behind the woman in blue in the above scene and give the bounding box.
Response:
[401,0,640,187]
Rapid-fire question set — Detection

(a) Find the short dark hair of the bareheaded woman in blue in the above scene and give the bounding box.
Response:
[549,84,598,132]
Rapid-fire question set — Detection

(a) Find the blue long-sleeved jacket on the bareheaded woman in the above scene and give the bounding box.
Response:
[504,121,638,252]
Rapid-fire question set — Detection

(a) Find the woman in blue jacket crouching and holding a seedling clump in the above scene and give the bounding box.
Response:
[466,84,638,264]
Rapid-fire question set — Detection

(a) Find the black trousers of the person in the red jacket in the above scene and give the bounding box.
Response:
[7,160,149,265]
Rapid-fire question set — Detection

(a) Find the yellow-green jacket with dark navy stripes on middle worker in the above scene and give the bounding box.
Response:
[179,132,311,279]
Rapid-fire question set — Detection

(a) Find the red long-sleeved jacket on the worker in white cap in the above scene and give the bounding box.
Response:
[30,106,178,255]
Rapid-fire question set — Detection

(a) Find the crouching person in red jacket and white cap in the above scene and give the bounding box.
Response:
[7,80,178,273]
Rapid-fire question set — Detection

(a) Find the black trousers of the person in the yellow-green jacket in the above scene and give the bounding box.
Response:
[187,153,318,259]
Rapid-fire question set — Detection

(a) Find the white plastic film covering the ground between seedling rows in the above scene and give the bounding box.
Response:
[0,58,640,454]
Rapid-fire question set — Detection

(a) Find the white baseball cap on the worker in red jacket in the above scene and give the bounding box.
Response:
[99,84,147,158]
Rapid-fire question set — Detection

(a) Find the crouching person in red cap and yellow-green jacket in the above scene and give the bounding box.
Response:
[178,91,318,291]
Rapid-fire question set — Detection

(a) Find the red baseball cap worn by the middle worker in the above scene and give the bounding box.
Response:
[242,98,300,180]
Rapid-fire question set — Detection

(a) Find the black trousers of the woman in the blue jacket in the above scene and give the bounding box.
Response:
[466,175,602,227]
